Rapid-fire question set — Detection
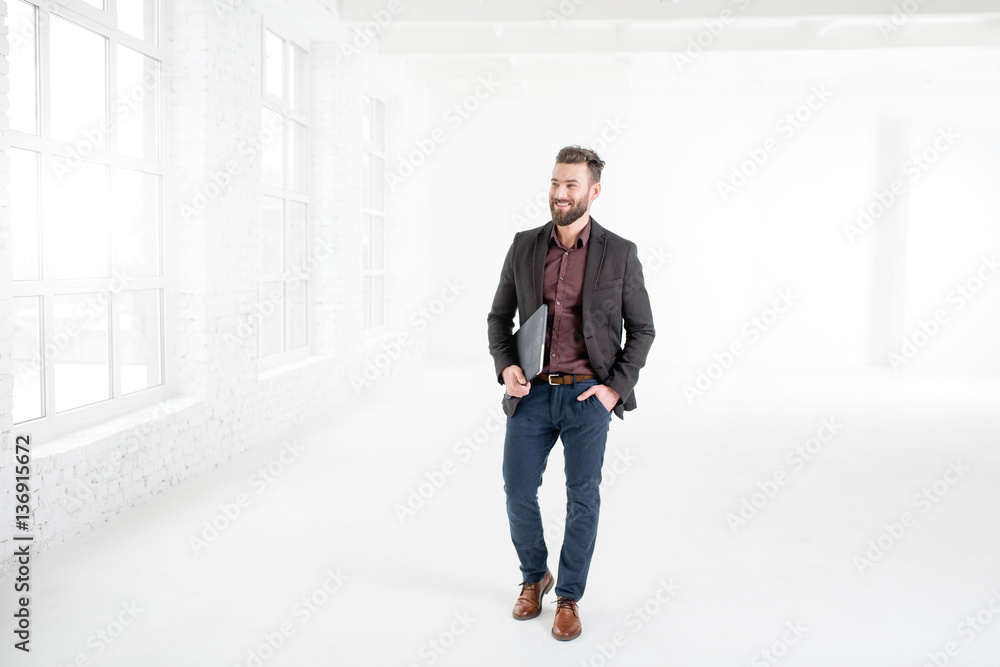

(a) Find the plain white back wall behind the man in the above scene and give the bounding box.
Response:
[411,49,1000,374]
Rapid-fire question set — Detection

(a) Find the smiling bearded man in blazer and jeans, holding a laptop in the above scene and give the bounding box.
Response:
[487,146,654,641]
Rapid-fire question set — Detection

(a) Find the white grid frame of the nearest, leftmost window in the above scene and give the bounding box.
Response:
[8,0,173,440]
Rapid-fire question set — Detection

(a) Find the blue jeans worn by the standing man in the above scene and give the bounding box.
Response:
[503,380,612,599]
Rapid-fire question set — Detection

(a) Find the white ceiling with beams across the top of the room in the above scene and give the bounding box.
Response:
[339,0,1000,82]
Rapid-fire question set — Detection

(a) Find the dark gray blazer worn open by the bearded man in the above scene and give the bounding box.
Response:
[486,217,655,419]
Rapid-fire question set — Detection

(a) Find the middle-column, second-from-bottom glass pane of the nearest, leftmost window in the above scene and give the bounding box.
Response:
[42,158,110,278]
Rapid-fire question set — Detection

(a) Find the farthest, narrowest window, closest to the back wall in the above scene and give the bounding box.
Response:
[361,95,385,329]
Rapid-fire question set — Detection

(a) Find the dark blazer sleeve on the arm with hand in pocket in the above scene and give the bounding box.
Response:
[604,243,656,403]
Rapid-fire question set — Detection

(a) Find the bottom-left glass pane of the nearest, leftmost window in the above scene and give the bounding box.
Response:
[13,296,42,424]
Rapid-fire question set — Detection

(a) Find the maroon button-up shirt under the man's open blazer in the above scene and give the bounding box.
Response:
[542,220,594,375]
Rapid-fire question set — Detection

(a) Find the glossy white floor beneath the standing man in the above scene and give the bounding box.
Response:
[0,361,1000,667]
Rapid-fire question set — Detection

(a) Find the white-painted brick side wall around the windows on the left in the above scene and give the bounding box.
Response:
[0,0,424,566]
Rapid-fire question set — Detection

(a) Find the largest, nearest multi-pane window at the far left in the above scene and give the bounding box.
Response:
[7,0,165,433]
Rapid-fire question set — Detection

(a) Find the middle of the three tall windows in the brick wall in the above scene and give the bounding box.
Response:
[258,28,311,367]
